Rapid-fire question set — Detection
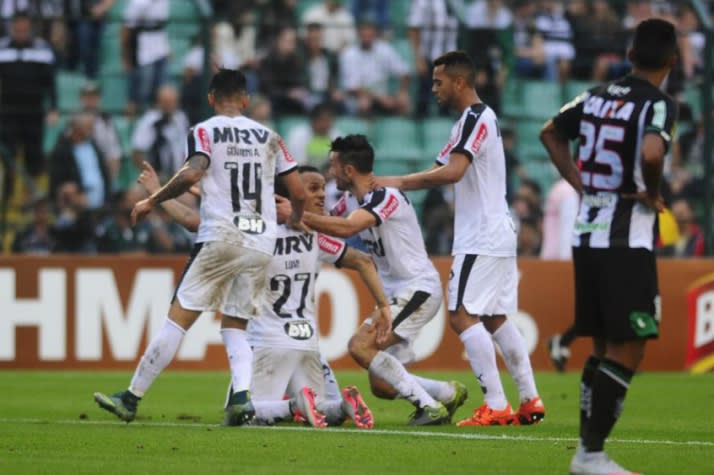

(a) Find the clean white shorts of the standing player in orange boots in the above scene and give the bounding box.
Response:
[449,254,518,316]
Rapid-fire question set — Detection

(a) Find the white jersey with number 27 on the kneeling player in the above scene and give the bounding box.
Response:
[248,225,347,351]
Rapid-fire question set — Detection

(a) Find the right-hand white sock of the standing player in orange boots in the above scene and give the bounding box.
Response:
[493,320,538,402]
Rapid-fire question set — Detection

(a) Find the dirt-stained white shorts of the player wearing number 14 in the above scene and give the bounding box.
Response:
[176,241,272,320]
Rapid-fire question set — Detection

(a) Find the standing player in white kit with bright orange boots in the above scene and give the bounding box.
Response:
[377,51,545,426]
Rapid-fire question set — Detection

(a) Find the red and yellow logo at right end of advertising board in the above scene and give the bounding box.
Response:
[685,274,714,373]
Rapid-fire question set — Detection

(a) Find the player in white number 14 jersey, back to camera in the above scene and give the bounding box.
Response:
[94,69,305,425]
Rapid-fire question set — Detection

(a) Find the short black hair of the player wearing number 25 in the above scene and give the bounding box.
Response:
[632,18,677,71]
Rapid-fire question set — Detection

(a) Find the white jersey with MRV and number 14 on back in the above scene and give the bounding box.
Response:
[186,115,297,254]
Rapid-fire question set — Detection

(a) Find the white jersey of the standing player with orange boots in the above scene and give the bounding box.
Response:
[436,103,516,257]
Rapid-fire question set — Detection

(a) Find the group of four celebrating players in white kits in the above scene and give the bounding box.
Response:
[94,52,545,429]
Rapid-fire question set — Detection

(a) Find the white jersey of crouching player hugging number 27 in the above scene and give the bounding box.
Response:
[332,187,441,299]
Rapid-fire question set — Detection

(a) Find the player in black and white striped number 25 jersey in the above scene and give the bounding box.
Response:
[541,19,677,474]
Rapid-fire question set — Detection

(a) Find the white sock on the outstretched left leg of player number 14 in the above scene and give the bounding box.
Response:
[129,318,186,397]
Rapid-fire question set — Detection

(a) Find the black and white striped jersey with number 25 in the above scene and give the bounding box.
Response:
[553,76,677,250]
